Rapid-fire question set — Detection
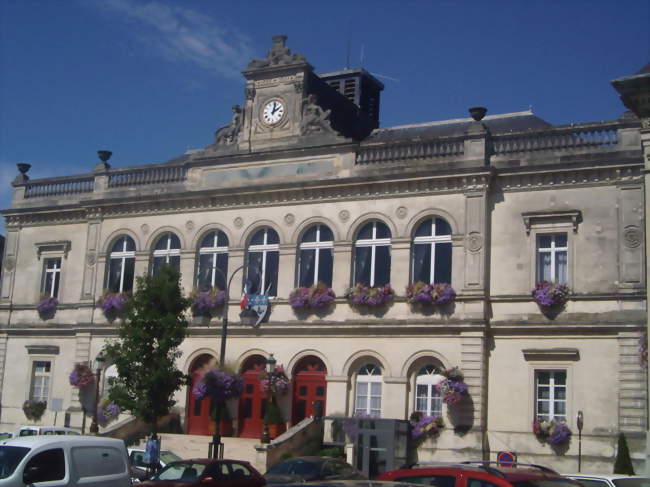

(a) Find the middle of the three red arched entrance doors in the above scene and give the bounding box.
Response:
[239,355,266,438]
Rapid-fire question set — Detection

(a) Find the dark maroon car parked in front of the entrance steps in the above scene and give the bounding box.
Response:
[137,458,266,487]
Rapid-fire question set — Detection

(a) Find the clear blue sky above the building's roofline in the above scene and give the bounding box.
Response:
[0,0,650,233]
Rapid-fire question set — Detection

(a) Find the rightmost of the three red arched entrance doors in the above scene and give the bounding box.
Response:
[291,357,327,424]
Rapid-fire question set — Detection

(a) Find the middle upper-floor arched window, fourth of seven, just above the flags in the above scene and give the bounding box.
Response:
[244,227,280,296]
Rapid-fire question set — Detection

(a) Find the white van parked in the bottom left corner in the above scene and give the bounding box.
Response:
[0,435,131,487]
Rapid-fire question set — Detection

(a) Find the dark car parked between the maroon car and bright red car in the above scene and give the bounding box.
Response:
[264,457,366,485]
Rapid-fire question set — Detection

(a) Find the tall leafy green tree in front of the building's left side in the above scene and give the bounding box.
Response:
[105,266,189,438]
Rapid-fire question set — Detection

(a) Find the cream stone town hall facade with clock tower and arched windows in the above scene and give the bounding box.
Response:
[0,36,647,472]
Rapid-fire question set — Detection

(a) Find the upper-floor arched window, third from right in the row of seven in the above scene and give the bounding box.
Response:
[298,225,334,287]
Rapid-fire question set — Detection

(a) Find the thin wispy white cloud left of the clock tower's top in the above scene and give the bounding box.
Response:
[94,0,254,77]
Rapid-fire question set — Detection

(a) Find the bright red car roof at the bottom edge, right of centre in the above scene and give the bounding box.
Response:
[377,462,581,487]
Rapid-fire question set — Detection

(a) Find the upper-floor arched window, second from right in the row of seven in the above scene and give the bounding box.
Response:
[354,222,391,286]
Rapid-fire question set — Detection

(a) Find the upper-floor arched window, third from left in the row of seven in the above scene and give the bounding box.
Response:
[196,230,228,291]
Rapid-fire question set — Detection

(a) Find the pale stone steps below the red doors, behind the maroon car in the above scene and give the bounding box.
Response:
[159,433,266,473]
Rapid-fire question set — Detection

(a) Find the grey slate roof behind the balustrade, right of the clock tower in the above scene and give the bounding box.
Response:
[365,110,552,142]
